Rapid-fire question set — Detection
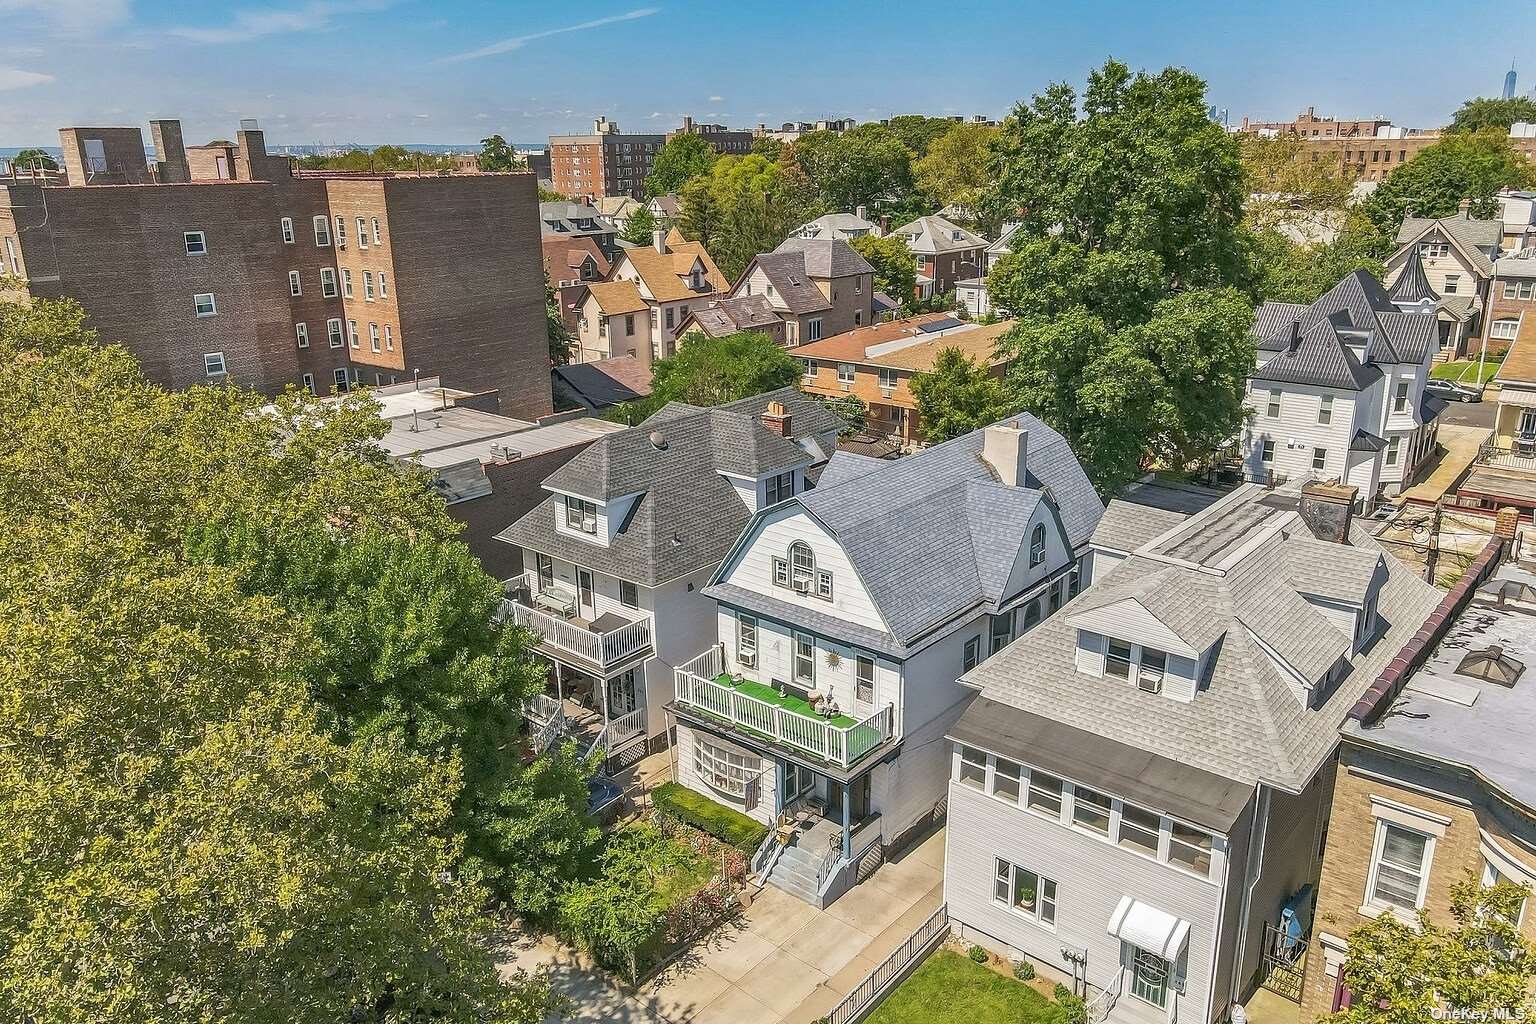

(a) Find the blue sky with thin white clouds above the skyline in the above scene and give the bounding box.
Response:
[0,0,1536,147]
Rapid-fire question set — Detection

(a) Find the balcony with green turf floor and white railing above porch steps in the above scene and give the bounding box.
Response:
[674,646,894,769]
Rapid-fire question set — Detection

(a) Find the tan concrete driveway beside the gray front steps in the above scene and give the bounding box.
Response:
[638,831,945,1024]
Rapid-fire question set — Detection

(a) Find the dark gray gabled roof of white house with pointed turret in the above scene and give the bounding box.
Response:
[1253,270,1438,367]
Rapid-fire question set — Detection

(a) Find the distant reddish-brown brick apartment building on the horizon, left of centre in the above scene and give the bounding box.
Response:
[550,117,753,200]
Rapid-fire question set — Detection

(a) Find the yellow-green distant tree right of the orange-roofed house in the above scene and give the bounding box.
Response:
[679,154,817,279]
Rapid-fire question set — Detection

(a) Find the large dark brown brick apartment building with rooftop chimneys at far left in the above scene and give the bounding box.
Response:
[0,121,553,418]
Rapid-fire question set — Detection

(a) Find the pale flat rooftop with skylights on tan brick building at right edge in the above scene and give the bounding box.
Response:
[1344,565,1536,808]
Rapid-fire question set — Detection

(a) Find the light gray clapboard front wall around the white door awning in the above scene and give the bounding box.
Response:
[945,781,1223,1024]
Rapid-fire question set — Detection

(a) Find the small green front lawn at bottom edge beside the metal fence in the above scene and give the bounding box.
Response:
[868,949,1063,1024]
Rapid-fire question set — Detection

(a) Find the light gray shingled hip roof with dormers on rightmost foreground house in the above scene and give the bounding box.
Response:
[966,487,1439,792]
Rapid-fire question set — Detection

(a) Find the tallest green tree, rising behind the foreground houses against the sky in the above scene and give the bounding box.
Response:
[983,61,1253,494]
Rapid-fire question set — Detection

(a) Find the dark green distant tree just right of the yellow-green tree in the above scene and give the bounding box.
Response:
[790,124,912,212]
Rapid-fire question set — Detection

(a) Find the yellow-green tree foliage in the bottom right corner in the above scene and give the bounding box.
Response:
[1326,878,1536,1024]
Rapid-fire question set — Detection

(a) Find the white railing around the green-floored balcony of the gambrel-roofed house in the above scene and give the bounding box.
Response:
[674,646,892,768]
